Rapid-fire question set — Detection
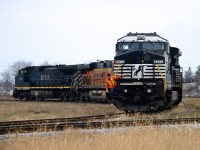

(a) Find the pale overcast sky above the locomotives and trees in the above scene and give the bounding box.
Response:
[0,0,200,71]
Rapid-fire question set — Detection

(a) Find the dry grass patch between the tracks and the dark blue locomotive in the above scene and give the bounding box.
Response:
[0,101,118,121]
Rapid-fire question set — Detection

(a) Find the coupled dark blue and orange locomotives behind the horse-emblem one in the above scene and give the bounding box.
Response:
[13,60,113,101]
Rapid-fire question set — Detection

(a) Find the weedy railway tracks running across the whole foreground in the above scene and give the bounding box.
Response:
[0,113,200,134]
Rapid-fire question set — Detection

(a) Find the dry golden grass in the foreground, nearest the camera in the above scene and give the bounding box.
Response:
[0,127,200,150]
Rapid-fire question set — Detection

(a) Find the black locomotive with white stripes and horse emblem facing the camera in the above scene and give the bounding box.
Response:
[113,33,182,112]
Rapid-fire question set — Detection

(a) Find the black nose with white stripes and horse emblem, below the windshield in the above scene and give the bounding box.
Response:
[114,50,166,101]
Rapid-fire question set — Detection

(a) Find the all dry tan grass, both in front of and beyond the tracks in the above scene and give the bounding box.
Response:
[0,98,200,150]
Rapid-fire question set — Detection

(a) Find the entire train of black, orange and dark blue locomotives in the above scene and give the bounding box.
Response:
[13,33,182,112]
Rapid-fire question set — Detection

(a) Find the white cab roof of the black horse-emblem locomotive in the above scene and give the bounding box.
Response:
[117,32,168,43]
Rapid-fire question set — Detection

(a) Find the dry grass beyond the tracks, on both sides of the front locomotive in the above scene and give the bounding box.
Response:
[0,98,200,121]
